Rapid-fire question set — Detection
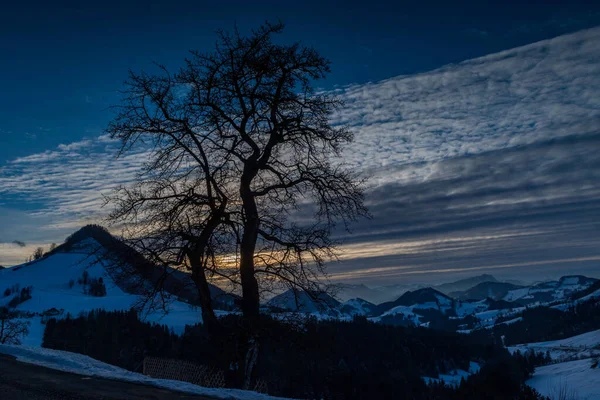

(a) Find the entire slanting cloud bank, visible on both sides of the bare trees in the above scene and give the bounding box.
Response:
[0,28,600,284]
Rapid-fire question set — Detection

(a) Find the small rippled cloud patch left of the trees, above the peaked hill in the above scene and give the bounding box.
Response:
[0,135,147,225]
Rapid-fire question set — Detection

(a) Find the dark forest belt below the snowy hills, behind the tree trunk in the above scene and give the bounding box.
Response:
[43,310,543,399]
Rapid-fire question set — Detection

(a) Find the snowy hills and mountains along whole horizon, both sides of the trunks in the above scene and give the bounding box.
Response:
[0,226,600,340]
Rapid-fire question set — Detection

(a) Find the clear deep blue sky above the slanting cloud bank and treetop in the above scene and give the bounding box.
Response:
[0,0,600,162]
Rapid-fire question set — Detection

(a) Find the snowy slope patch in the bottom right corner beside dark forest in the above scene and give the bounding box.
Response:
[527,358,600,400]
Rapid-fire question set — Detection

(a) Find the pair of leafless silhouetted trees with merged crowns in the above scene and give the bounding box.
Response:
[108,23,367,382]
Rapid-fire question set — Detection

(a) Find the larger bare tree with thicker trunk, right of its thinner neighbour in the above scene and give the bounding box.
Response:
[180,23,367,320]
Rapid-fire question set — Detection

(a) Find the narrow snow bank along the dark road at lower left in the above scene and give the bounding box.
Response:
[0,344,290,400]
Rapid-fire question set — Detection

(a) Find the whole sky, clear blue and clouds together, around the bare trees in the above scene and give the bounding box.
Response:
[0,1,600,286]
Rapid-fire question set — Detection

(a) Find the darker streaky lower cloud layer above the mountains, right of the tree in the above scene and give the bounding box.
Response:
[330,134,600,284]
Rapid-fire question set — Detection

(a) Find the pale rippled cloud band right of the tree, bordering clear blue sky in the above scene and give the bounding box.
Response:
[335,29,600,177]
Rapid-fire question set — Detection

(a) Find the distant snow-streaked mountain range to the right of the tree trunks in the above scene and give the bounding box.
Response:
[267,275,600,332]
